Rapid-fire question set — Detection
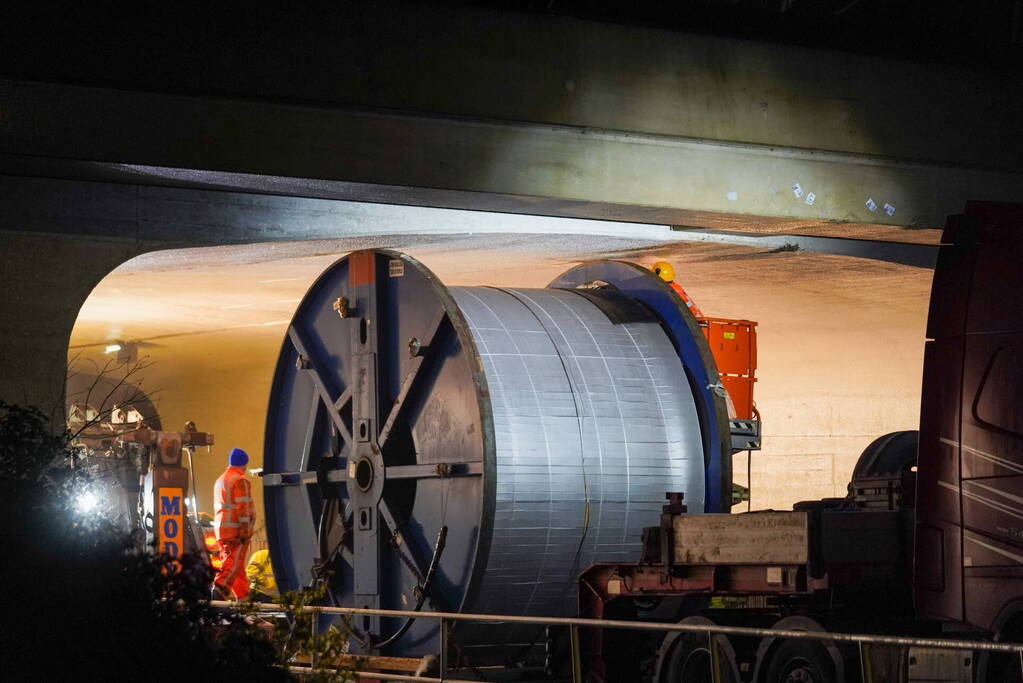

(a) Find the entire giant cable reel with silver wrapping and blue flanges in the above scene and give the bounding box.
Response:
[263,251,730,654]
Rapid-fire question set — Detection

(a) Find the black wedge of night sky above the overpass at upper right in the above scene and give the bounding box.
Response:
[444,0,1023,70]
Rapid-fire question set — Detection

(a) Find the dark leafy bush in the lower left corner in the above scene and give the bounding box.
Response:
[0,403,292,682]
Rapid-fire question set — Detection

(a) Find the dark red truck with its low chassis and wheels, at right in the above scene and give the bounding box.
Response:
[579,203,1023,683]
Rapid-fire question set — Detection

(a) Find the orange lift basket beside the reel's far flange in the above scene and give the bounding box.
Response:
[699,318,757,419]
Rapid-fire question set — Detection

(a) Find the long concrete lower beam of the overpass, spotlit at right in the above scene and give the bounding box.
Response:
[0,82,1023,227]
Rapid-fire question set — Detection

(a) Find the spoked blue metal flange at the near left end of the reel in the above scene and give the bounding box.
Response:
[263,251,487,654]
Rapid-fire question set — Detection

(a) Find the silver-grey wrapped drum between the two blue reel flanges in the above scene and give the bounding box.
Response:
[451,287,704,616]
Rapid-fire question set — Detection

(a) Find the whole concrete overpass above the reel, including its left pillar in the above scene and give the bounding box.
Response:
[0,3,1023,408]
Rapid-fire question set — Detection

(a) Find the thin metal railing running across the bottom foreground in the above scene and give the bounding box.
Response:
[210,600,1023,683]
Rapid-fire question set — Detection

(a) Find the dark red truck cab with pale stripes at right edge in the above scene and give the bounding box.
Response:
[914,202,1023,641]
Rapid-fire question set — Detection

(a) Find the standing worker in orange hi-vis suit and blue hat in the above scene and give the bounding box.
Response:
[213,448,256,600]
